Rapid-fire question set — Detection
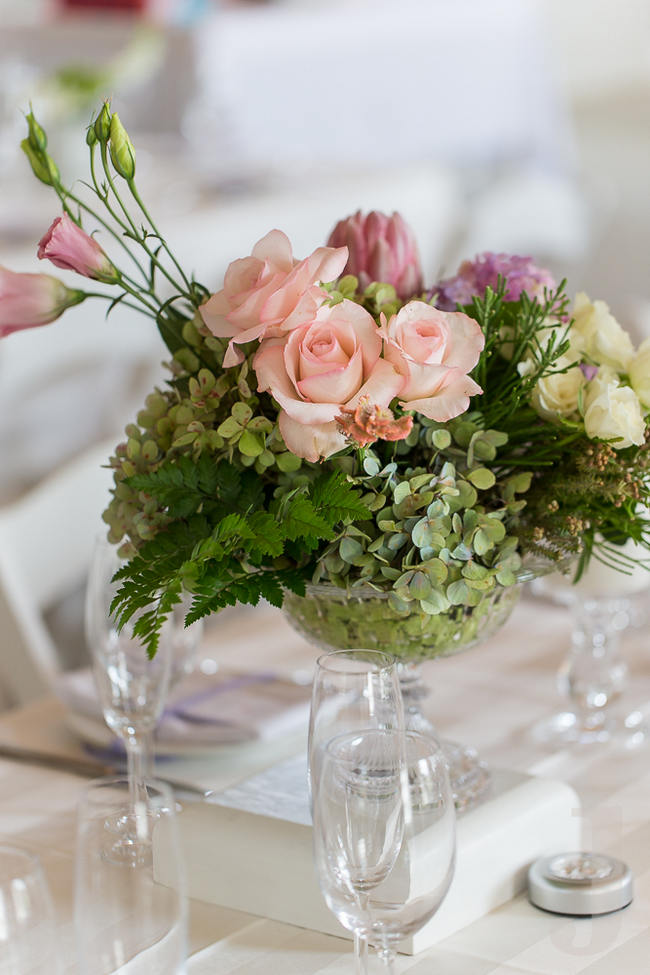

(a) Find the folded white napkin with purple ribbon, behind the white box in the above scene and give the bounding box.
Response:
[57,668,310,747]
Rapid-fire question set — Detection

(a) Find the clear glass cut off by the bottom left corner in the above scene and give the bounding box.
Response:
[0,846,61,975]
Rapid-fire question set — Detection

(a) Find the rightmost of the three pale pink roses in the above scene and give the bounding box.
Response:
[381,301,485,423]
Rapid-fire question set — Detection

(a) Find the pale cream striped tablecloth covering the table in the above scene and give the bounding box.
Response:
[0,597,650,975]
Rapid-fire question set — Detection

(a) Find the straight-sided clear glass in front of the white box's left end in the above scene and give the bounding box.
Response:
[74,778,187,975]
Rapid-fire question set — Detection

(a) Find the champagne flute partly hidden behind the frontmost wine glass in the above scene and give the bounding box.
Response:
[309,650,404,973]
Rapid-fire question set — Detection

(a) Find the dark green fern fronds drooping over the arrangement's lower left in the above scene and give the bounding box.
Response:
[109,462,369,655]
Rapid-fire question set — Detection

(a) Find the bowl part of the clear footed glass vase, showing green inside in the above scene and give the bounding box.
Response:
[283,578,526,663]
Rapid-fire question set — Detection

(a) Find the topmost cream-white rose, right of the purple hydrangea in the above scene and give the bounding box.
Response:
[569,291,634,372]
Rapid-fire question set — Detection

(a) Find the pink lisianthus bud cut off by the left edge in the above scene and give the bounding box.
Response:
[0,266,85,338]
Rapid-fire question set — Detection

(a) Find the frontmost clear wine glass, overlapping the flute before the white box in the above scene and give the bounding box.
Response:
[314,730,455,973]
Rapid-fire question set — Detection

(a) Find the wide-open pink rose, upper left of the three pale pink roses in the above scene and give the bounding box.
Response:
[200,230,348,368]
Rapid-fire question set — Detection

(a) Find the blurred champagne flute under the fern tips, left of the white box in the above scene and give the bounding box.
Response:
[85,540,173,824]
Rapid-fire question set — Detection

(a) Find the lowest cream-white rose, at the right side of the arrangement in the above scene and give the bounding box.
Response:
[585,366,645,450]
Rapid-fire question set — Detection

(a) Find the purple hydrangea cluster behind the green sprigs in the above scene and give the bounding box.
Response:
[431,251,555,311]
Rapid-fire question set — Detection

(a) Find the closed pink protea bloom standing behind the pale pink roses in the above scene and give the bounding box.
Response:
[327,210,422,300]
